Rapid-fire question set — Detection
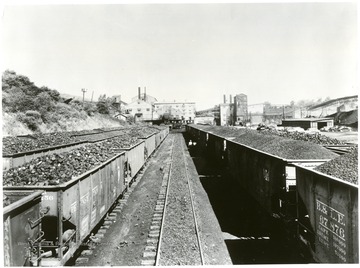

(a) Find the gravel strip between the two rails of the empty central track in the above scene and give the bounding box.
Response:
[160,137,201,266]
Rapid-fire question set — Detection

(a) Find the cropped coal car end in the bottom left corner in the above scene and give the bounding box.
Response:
[3,190,44,266]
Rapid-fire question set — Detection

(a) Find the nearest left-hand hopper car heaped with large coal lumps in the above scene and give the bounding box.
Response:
[3,147,126,266]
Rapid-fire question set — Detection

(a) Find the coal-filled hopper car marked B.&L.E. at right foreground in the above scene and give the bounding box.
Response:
[296,149,359,263]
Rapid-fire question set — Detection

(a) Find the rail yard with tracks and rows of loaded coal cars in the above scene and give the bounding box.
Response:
[3,124,359,266]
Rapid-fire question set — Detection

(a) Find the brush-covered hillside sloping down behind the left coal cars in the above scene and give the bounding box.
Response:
[2,70,131,136]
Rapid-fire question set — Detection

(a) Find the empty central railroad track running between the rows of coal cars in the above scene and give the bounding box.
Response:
[142,135,205,266]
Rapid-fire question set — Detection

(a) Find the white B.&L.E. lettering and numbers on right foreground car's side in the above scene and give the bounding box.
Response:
[316,200,347,262]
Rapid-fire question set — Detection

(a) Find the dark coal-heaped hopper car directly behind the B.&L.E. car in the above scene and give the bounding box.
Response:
[186,124,357,262]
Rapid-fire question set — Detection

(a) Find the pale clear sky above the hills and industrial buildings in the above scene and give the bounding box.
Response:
[1,1,359,110]
